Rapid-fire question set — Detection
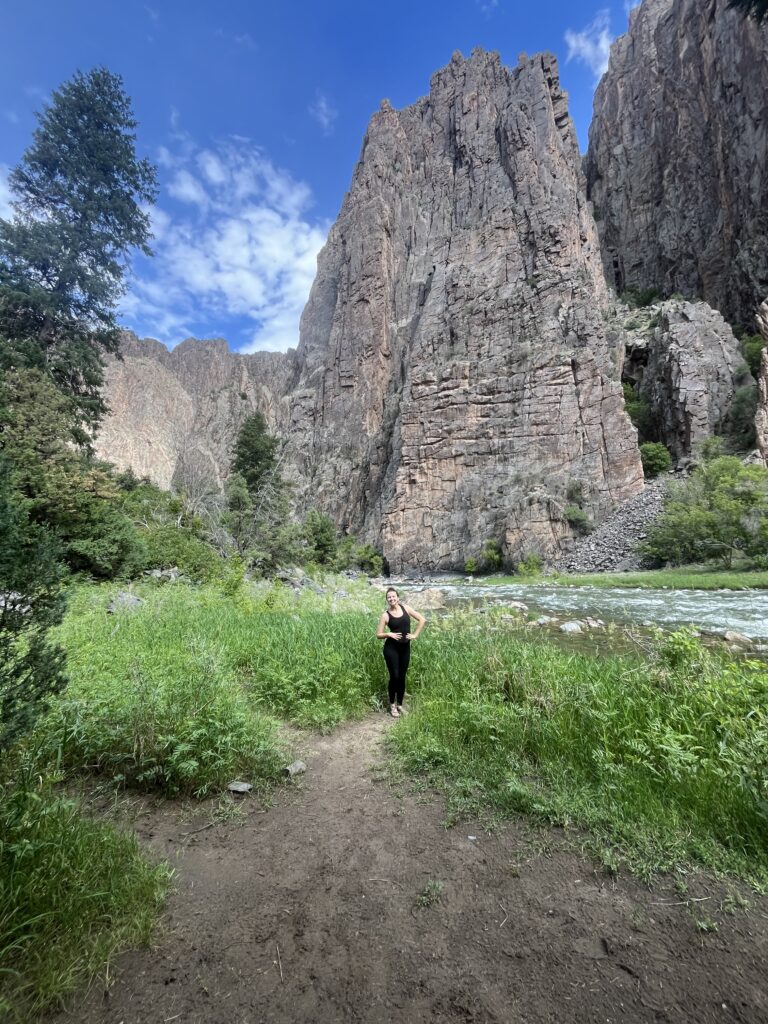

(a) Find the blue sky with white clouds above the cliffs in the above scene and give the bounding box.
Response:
[0,0,628,351]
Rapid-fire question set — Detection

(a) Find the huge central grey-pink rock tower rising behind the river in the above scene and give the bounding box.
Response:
[290,51,643,569]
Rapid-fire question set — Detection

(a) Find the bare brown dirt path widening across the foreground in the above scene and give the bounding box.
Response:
[54,714,768,1024]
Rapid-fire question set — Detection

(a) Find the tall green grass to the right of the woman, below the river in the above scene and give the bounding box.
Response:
[390,624,768,884]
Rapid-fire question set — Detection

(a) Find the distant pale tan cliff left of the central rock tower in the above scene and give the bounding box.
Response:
[95,332,295,493]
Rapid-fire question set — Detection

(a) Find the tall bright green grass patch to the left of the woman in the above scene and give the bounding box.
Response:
[43,585,383,796]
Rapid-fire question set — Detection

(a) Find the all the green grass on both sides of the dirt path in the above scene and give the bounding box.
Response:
[0,580,768,1020]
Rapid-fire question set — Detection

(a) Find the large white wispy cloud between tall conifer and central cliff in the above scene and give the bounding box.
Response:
[123,138,330,351]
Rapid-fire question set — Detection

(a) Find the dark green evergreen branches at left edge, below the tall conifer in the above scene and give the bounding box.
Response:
[0,460,66,760]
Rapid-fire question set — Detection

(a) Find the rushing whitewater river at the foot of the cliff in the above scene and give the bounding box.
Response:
[394,579,768,642]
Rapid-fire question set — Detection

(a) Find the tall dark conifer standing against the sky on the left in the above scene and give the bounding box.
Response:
[0,68,157,432]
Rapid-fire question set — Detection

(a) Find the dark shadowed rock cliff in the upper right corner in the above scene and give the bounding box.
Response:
[585,0,768,326]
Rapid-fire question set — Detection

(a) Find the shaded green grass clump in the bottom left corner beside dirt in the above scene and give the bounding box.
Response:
[0,766,171,1024]
